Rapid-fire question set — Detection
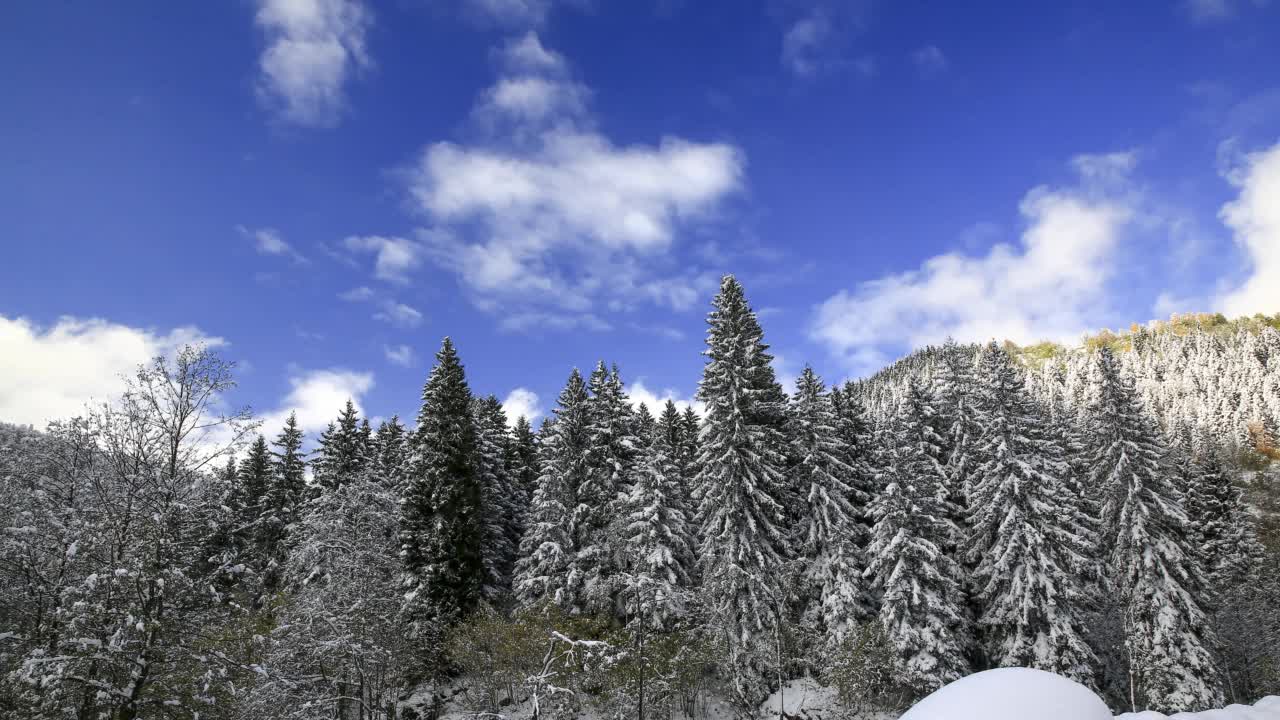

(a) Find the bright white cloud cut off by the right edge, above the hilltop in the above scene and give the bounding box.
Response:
[1217,143,1280,316]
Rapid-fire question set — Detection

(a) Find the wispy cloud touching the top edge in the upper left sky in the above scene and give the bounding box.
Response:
[255,0,372,127]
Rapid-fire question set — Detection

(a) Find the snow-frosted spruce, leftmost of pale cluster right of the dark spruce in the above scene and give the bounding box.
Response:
[515,368,590,612]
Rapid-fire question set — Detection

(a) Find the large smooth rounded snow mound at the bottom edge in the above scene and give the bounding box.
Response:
[901,667,1116,720]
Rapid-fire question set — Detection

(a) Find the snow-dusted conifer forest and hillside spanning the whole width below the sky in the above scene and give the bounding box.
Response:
[0,277,1280,720]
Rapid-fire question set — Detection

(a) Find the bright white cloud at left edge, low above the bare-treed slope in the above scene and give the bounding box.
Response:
[0,315,225,427]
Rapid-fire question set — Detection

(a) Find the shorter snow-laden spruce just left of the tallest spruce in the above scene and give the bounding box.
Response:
[616,425,694,629]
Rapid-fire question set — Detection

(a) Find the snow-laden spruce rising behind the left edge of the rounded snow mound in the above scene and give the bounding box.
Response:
[865,377,970,694]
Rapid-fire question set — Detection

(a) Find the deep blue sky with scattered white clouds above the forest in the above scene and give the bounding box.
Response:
[0,0,1280,432]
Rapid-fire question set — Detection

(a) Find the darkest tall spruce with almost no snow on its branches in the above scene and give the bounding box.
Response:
[399,337,485,622]
